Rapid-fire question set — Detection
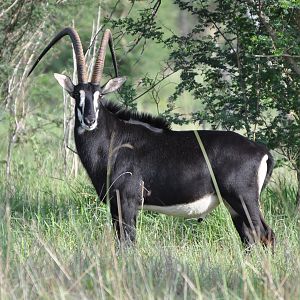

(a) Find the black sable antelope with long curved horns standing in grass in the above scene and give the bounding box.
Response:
[29,28,275,245]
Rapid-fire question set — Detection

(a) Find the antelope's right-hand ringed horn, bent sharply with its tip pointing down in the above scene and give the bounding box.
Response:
[91,29,118,84]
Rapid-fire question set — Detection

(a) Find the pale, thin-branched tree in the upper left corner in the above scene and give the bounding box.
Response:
[0,0,57,177]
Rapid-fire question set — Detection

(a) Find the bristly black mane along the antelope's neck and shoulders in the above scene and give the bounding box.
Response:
[102,100,171,130]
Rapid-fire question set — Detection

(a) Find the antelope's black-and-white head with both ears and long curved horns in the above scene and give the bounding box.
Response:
[28,28,126,131]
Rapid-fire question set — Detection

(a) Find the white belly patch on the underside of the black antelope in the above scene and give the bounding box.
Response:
[140,194,219,218]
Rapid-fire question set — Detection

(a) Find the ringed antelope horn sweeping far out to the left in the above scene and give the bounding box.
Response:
[27,27,88,83]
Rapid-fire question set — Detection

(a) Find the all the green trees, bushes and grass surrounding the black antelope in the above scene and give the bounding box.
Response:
[0,0,300,299]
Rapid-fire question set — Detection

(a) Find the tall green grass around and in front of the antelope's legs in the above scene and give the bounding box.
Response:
[0,154,300,299]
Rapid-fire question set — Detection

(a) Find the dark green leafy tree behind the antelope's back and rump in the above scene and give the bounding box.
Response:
[165,0,300,209]
